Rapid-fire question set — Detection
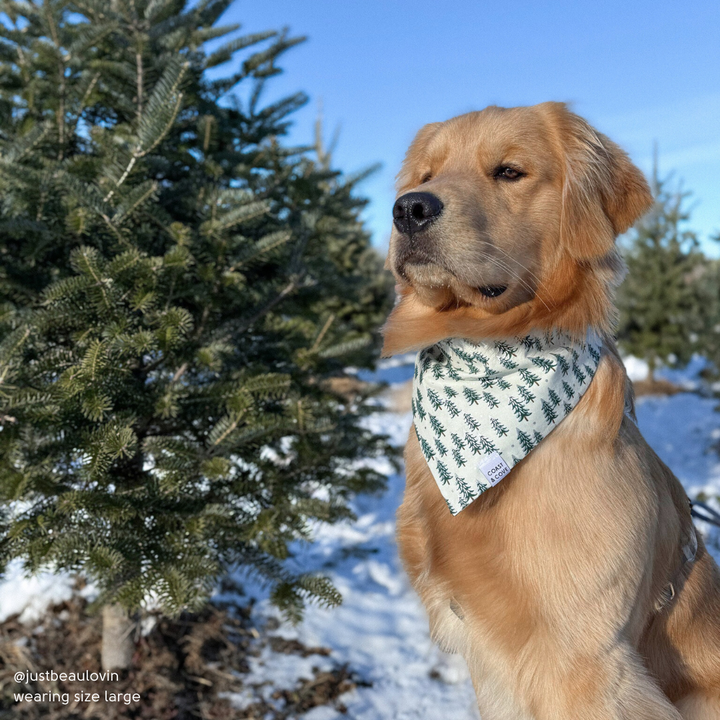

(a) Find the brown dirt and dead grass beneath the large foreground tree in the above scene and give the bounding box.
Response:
[0,584,368,720]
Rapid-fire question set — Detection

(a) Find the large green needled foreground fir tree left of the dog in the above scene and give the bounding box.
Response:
[0,0,390,668]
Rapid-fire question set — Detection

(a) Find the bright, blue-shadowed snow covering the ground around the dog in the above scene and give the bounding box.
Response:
[0,357,720,720]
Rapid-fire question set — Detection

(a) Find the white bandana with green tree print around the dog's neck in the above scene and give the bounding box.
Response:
[412,331,602,515]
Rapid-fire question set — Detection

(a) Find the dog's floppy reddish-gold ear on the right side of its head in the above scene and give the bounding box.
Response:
[545,103,653,260]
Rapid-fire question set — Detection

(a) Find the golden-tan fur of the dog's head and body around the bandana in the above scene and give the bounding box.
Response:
[384,103,720,720]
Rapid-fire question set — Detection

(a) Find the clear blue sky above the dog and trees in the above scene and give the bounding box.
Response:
[223,0,720,255]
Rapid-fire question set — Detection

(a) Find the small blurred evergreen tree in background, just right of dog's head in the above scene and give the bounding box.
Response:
[617,149,704,382]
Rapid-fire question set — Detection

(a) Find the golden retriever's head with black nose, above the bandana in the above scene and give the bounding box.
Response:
[385,103,652,353]
